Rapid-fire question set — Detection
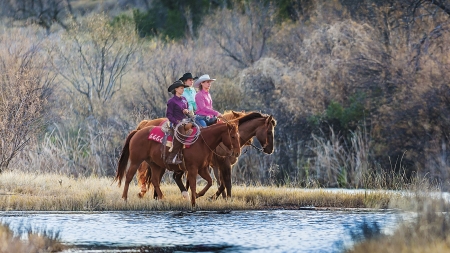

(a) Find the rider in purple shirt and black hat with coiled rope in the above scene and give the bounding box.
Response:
[166,80,192,164]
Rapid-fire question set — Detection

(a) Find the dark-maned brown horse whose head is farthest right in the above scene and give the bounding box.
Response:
[147,112,276,199]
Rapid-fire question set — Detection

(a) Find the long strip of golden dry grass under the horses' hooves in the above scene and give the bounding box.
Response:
[0,172,408,211]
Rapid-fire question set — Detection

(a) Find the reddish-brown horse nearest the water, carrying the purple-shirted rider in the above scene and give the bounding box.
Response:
[115,120,241,206]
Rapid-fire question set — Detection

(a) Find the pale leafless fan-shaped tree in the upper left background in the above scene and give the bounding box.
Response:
[54,15,140,115]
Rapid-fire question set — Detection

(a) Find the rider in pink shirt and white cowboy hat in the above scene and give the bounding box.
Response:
[194,75,222,127]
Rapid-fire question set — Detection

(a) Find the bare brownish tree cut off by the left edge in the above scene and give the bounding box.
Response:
[0,31,55,172]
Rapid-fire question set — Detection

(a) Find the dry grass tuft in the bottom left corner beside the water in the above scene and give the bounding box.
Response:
[0,224,65,253]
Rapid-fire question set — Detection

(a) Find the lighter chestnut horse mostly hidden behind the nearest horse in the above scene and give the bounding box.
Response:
[136,111,245,199]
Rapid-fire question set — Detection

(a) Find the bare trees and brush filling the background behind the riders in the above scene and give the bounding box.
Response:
[0,0,450,190]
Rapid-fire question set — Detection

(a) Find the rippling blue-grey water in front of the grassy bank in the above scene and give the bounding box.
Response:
[0,210,399,253]
